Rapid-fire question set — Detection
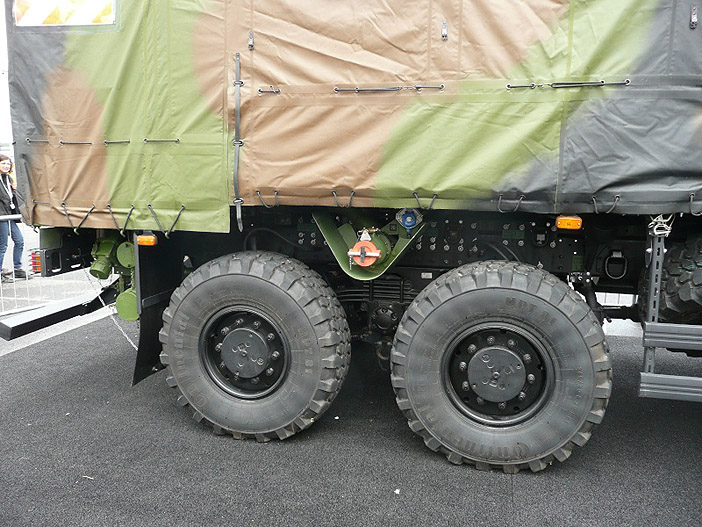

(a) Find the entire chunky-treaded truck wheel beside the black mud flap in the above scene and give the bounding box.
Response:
[159,251,350,441]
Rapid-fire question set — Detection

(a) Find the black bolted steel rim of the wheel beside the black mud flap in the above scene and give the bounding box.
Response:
[199,306,290,399]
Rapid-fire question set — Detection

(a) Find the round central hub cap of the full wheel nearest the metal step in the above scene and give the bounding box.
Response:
[468,346,526,403]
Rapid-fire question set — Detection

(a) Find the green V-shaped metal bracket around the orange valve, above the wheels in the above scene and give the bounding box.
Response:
[312,212,427,280]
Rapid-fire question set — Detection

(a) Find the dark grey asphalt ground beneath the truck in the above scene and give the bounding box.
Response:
[0,318,702,526]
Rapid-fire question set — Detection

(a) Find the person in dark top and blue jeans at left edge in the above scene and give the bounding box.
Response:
[0,154,27,282]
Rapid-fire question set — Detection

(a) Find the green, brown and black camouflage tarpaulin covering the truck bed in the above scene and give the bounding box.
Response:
[6,0,702,232]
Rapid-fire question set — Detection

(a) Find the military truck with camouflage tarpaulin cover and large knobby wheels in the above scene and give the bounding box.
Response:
[2,0,702,473]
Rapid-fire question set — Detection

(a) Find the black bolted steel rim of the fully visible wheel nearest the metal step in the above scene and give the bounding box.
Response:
[442,323,555,427]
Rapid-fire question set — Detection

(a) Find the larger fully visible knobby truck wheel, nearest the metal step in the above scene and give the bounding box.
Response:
[391,262,612,473]
